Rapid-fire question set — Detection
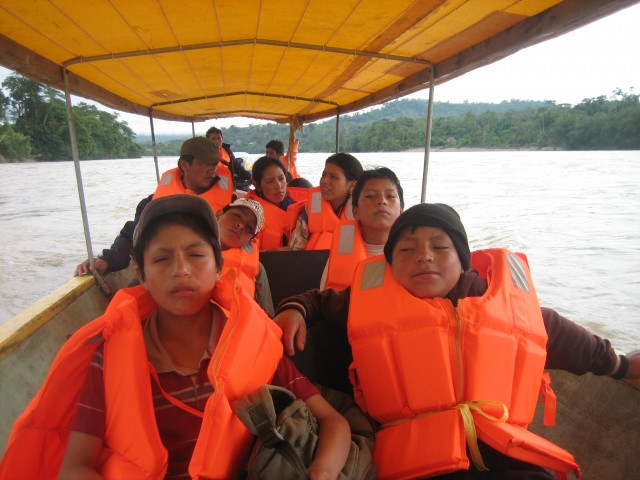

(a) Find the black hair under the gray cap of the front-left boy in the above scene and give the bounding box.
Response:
[131,213,222,280]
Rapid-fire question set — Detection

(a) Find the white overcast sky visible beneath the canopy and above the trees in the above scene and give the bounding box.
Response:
[0,4,640,135]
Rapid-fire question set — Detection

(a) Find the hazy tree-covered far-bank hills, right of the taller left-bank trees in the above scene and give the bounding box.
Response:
[139,90,640,155]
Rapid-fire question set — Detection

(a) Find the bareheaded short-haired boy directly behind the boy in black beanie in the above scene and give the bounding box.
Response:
[320,167,404,290]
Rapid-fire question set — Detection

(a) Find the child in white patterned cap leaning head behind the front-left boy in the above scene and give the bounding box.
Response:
[216,198,274,317]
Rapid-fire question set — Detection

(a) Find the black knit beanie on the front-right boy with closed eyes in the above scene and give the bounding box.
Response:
[384,203,471,271]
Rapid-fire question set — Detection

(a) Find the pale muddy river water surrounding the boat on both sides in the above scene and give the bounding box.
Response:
[0,151,640,351]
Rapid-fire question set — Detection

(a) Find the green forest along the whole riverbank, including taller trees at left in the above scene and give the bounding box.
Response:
[0,74,640,161]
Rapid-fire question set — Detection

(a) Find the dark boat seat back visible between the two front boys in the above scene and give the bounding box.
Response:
[260,250,352,394]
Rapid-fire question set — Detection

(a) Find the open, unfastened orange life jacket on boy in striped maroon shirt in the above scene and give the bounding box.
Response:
[0,272,282,480]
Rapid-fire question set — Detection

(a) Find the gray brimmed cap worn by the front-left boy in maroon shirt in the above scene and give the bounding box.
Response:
[133,193,220,247]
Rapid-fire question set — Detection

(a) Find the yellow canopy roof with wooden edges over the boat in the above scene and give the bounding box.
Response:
[0,0,638,123]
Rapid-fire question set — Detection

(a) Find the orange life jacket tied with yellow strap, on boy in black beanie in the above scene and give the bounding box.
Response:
[347,249,580,479]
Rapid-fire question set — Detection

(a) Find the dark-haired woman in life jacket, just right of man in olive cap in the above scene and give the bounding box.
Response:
[245,157,308,250]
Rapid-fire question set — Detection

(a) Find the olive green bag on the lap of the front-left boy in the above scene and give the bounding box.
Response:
[232,385,376,480]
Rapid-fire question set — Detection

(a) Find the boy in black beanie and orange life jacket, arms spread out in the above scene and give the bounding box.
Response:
[275,204,640,480]
